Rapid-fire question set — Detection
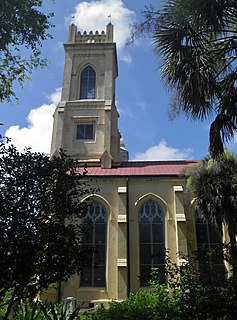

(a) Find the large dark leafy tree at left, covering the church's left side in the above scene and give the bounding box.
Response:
[0,143,88,319]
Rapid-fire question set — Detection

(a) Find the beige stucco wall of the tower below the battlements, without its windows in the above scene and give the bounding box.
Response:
[51,36,120,162]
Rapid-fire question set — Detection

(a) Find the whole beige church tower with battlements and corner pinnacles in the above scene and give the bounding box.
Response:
[51,23,128,168]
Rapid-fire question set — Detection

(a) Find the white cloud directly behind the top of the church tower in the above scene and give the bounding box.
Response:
[70,0,135,63]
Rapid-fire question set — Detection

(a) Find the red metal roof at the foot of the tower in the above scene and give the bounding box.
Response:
[78,160,198,176]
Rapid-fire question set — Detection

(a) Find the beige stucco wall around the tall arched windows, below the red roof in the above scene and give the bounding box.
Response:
[56,177,193,304]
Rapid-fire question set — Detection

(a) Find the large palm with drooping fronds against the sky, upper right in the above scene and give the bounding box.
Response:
[133,0,237,157]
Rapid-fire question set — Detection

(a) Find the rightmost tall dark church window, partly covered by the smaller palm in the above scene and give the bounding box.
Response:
[195,214,225,281]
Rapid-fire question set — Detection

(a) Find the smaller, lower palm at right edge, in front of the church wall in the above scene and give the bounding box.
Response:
[186,150,237,276]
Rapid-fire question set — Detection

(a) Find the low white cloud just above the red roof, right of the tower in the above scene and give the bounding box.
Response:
[134,139,192,161]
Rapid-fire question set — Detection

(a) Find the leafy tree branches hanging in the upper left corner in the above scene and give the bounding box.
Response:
[0,0,52,102]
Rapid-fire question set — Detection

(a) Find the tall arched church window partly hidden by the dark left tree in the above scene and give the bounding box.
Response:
[80,203,107,287]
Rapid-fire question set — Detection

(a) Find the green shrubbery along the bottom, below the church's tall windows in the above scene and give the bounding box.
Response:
[80,261,237,320]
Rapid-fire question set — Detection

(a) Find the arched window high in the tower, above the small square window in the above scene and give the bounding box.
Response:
[80,67,96,99]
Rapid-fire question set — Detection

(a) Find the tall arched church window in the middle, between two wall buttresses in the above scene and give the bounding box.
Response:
[139,201,165,287]
